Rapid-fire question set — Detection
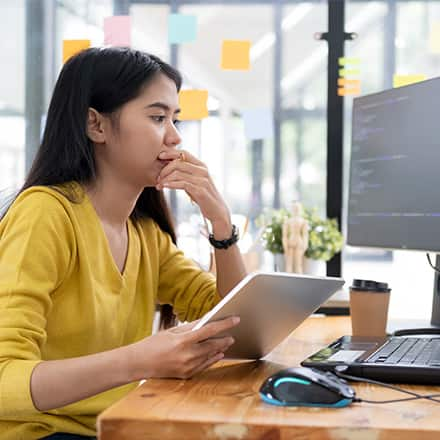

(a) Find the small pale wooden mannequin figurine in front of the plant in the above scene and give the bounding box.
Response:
[282,202,309,273]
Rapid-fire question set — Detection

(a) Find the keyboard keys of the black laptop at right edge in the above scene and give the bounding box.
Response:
[364,337,440,367]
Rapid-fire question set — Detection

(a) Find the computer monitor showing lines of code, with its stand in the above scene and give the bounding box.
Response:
[347,78,440,327]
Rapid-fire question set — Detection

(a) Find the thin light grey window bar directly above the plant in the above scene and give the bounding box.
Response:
[273,0,283,209]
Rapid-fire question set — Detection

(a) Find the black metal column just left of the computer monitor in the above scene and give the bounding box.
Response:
[327,0,346,276]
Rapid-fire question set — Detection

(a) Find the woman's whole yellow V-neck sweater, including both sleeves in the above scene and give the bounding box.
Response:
[0,185,220,440]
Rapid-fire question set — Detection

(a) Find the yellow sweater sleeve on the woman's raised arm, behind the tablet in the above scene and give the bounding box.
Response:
[157,226,221,322]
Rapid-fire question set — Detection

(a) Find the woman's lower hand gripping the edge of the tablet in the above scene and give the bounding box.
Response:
[127,317,240,381]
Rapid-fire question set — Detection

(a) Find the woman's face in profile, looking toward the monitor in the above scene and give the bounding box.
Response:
[96,74,181,187]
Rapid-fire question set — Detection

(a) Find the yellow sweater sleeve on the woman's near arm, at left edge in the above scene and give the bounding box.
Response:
[0,191,74,417]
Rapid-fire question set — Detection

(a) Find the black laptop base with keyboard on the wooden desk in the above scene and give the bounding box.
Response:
[301,333,440,385]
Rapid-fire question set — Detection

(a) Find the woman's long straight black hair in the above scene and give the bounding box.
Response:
[6,47,182,328]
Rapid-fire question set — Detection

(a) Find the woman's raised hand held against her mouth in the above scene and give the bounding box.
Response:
[156,150,230,229]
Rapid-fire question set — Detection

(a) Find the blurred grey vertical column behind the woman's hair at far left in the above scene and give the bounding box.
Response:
[24,0,44,173]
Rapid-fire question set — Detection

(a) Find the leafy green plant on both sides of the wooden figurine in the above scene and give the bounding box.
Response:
[257,208,344,272]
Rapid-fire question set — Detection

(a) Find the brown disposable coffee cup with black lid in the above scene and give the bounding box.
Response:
[350,279,391,337]
